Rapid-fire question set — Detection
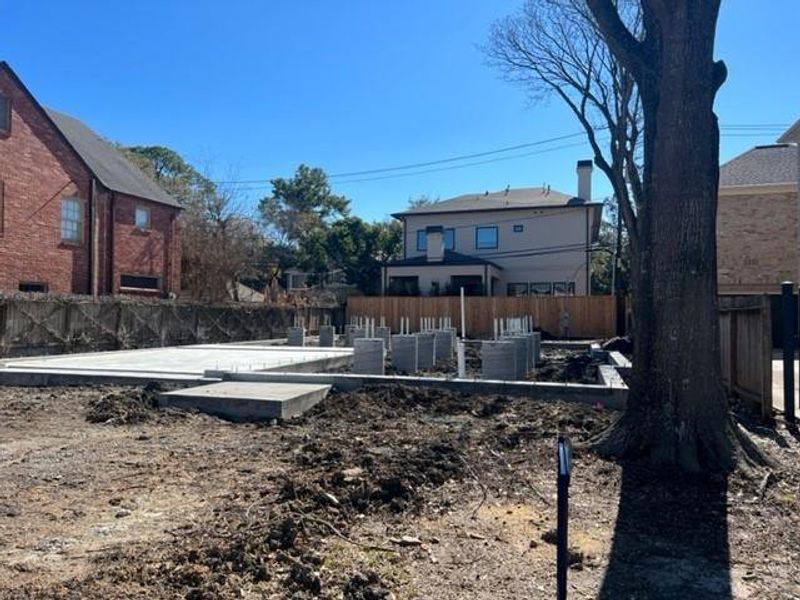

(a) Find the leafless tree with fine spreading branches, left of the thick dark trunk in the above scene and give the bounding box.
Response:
[485,0,642,244]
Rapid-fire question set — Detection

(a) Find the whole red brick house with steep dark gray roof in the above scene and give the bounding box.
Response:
[0,61,181,295]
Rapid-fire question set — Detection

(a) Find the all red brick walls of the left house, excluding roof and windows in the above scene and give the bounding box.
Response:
[0,68,180,294]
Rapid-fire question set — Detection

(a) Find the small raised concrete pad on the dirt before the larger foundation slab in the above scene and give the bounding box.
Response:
[159,381,331,421]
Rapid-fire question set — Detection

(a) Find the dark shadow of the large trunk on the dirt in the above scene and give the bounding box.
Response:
[599,465,733,600]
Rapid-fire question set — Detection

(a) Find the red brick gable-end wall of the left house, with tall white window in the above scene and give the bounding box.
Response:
[0,70,90,293]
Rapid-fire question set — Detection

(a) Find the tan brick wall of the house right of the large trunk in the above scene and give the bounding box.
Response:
[717,190,799,293]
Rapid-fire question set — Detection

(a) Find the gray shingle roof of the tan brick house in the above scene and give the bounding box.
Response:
[719,144,798,187]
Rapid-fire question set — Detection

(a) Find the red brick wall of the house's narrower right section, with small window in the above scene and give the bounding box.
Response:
[111,194,180,294]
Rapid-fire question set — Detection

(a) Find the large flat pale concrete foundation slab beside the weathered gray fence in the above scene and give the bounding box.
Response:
[0,344,353,385]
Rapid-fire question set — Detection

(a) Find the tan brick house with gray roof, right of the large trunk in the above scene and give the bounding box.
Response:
[717,121,800,294]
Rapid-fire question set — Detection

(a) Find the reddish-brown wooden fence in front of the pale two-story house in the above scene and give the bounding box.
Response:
[347,296,616,338]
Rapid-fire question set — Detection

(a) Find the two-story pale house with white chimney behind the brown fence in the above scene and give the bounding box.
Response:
[382,160,603,296]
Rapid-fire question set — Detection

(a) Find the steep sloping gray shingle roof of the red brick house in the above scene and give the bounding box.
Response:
[44,108,180,207]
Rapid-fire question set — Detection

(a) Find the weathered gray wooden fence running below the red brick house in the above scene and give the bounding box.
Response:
[0,296,334,356]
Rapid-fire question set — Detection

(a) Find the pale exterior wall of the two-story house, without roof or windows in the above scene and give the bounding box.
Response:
[404,206,596,296]
